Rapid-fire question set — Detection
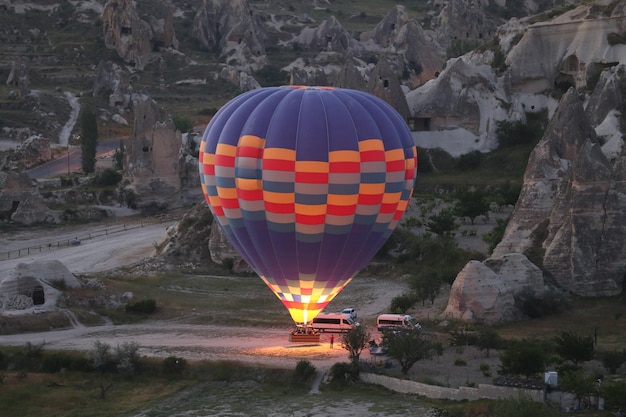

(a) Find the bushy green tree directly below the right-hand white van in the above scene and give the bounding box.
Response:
[383,329,435,375]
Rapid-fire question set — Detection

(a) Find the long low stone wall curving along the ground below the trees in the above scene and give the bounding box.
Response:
[359,372,544,402]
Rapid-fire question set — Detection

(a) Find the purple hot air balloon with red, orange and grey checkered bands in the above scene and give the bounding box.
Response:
[199,86,417,325]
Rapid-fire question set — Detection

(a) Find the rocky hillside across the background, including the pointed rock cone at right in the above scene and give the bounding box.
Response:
[0,0,626,321]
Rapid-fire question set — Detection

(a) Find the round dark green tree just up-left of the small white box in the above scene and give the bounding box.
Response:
[499,339,548,378]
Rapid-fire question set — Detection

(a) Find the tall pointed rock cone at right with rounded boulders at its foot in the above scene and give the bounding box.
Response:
[446,83,626,321]
